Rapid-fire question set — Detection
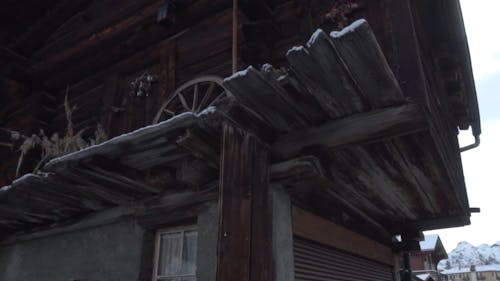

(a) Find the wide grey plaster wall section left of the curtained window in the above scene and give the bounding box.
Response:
[0,220,144,281]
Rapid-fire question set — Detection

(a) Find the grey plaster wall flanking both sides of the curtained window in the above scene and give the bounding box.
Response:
[0,202,219,281]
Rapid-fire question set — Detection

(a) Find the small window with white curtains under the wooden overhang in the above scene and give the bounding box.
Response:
[153,227,198,281]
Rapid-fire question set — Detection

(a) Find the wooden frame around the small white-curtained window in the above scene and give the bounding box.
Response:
[152,224,198,281]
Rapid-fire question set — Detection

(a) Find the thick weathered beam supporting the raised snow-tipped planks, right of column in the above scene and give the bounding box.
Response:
[272,104,428,159]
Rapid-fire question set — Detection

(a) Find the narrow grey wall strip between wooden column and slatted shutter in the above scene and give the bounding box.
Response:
[271,187,294,281]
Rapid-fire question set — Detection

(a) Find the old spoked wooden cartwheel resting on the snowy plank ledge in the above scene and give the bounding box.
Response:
[153,75,231,124]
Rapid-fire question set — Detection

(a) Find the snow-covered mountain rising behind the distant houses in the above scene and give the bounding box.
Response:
[438,238,500,269]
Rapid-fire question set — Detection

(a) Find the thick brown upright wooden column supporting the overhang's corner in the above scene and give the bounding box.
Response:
[217,124,272,281]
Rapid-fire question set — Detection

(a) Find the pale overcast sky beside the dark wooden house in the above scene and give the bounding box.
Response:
[426,0,500,252]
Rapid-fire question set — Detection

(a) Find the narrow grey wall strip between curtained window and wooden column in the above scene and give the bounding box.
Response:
[196,203,219,281]
